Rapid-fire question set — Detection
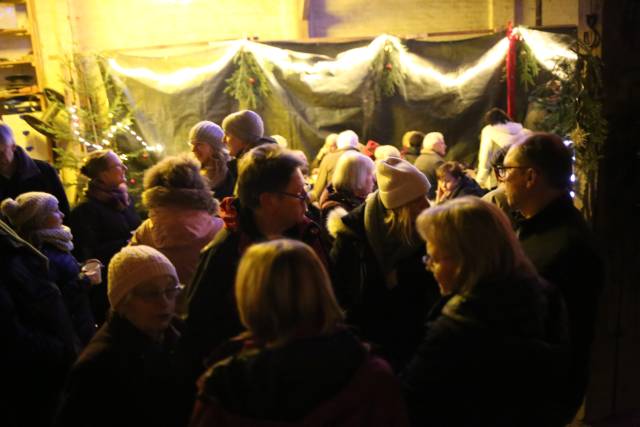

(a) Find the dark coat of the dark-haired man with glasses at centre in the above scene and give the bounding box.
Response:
[183,198,329,381]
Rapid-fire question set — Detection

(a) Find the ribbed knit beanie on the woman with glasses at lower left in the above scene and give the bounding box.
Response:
[107,245,178,308]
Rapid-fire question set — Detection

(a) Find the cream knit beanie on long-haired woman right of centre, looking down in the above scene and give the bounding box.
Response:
[376,157,431,209]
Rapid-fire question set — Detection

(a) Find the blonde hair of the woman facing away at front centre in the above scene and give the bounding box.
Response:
[235,239,344,345]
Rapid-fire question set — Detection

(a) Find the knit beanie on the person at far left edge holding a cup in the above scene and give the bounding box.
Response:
[0,191,58,229]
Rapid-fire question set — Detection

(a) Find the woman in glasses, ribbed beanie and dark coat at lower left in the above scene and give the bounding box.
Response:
[57,245,193,427]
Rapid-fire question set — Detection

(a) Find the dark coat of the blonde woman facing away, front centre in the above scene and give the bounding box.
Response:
[191,331,408,427]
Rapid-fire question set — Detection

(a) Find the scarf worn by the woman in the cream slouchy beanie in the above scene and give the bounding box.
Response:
[364,191,420,289]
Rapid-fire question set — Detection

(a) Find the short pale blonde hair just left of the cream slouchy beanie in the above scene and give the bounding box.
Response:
[331,151,375,197]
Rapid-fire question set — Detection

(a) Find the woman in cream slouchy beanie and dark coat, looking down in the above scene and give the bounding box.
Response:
[331,157,438,367]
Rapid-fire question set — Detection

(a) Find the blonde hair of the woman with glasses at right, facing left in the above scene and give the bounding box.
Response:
[416,196,537,292]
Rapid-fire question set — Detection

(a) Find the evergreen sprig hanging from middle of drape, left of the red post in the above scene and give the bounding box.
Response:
[370,39,405,101]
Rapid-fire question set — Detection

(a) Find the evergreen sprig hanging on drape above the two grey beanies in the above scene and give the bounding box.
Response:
[224,47,270,110]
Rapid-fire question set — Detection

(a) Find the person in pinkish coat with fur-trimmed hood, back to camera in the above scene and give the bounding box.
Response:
[131,155,223,316]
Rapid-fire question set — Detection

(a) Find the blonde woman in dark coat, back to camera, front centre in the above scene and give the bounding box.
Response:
[190,239,408,427]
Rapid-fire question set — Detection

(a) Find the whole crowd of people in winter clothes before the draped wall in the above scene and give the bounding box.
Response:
[0,104,603,427]
